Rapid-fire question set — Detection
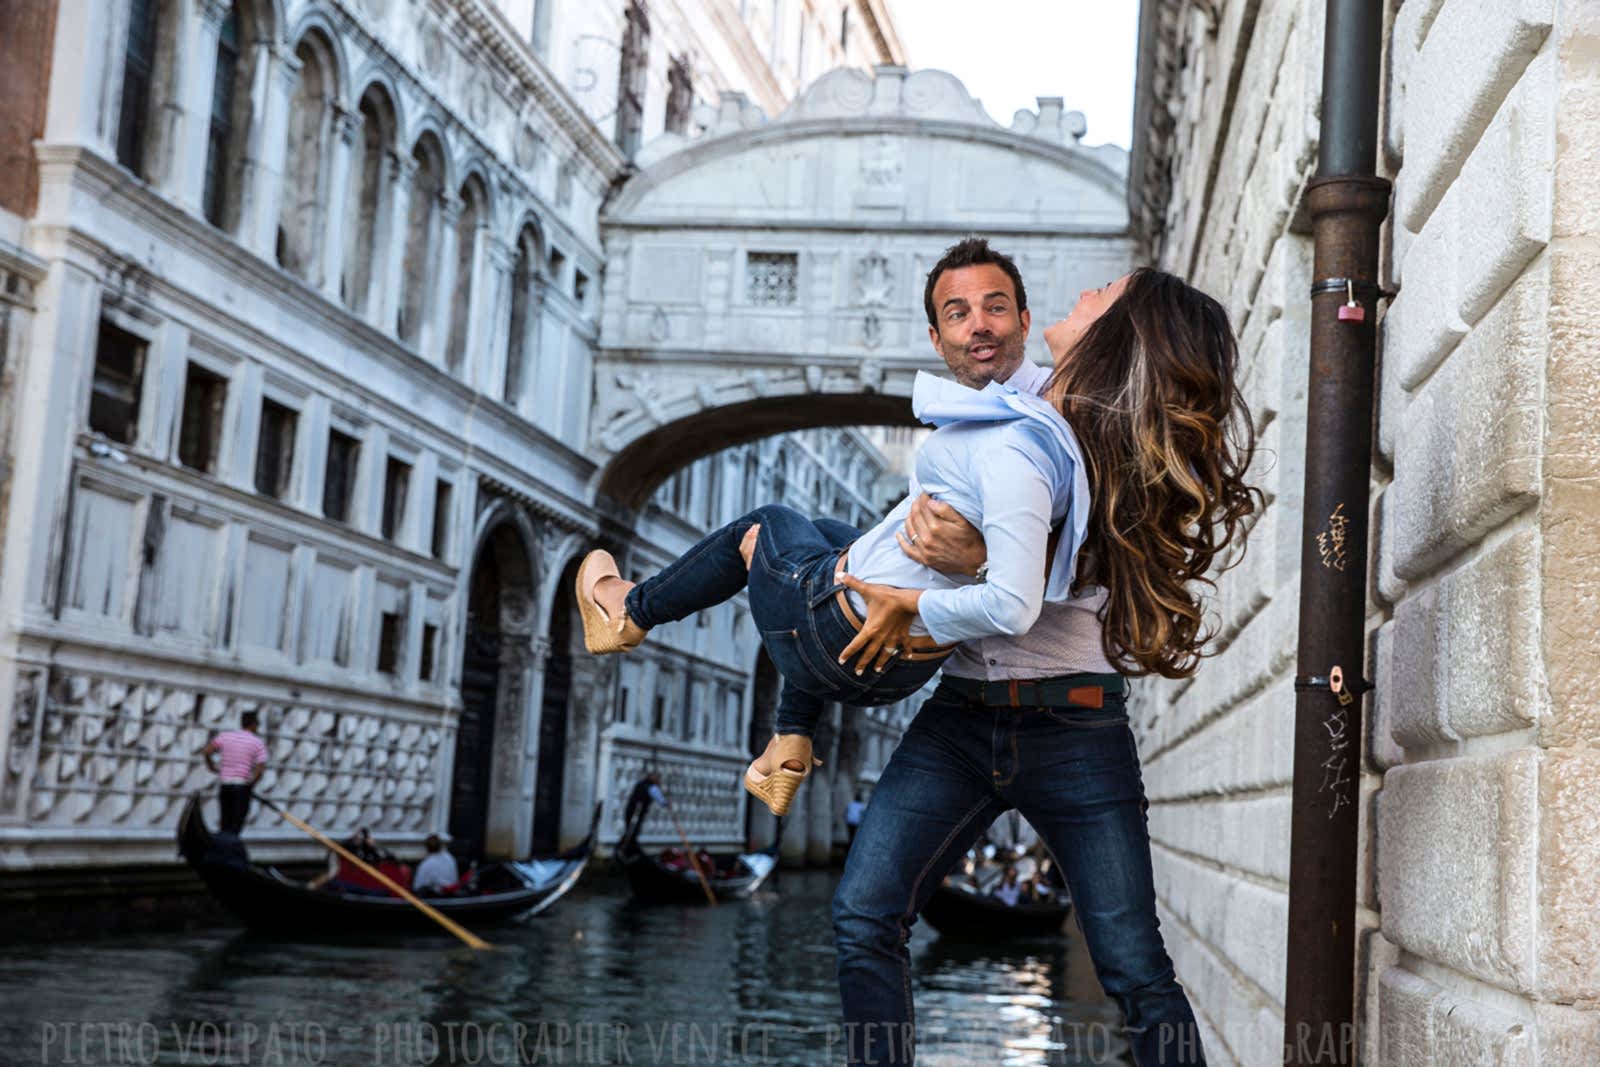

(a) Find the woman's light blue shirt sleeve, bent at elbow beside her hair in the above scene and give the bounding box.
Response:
[917,437,1070,645]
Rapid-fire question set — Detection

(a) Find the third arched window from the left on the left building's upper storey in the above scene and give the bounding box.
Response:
[278,37,333,285]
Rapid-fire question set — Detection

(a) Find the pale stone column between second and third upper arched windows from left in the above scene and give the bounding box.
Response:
[238,42,301,259]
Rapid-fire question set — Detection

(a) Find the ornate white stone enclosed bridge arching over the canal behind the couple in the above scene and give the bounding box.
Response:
[590,67,1133,507]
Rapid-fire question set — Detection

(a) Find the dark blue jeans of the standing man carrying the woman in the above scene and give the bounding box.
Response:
[834,686,1205,1067]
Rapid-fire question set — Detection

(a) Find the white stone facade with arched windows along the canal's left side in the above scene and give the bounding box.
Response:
[0,0,902,867]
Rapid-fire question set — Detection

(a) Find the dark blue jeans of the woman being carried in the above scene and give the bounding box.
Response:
[627,504,942,737]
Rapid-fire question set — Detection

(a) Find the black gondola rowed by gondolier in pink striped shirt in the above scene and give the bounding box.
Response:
[178,792,600,934]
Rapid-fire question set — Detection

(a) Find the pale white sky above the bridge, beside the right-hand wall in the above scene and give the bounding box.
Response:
[890,0,1139,147]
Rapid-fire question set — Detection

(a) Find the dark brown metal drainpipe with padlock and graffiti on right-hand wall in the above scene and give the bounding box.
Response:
[1283,0,1389,1065]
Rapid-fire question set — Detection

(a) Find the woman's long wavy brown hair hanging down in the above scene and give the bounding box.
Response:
[1046,269,1262,678]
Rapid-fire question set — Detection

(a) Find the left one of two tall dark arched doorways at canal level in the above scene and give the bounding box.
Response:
[450,522,533,859]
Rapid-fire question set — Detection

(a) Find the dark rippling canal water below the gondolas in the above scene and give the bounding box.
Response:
[0,872,1128,1067]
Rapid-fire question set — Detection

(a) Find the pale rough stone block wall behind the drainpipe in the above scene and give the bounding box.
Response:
[1130,0,1600,1065]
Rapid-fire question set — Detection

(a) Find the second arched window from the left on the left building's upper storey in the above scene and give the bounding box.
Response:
[200,0,262,232]
